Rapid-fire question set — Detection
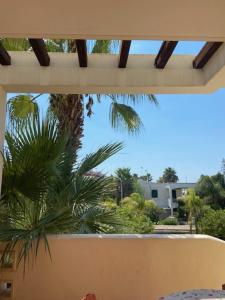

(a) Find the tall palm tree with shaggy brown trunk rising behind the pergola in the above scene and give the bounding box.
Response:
[2,39,158,158]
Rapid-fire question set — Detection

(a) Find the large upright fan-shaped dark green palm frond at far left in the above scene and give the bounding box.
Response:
[3,118,66,203]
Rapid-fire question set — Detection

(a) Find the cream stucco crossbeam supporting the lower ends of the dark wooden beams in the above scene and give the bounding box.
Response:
[0,43,225,94]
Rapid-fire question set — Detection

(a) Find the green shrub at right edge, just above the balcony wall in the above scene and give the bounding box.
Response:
[201,209,225,240]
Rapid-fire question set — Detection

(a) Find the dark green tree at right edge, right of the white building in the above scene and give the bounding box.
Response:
[195,173,225,209]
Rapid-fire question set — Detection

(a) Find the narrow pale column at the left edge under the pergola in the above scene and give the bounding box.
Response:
[0,86,6,193]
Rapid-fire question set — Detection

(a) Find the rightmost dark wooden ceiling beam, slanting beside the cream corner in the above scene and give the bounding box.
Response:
[193,42,223,69]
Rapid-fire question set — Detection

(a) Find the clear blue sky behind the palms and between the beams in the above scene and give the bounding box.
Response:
[7,41,225,182]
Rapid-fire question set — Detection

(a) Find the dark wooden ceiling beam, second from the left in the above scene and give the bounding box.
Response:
[29,39,50,67]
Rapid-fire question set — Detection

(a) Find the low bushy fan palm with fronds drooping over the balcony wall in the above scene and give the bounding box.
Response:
[0,118,122,265]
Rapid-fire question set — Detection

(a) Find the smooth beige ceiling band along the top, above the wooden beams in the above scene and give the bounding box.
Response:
[0,0,225,41]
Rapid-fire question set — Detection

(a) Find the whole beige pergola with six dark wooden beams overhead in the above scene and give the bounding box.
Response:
[0,0,225,189]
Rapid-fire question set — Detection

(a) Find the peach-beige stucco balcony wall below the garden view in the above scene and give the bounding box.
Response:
[0,235,225,300]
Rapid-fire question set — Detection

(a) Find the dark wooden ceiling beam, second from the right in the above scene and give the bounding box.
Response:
[155,41,178,69]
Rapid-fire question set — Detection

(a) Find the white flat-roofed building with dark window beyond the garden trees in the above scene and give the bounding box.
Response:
[139,179,195,215]
